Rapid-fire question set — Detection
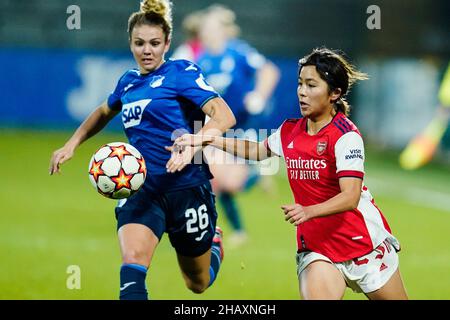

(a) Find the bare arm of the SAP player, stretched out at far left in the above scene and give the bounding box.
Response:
[49,102,119,175]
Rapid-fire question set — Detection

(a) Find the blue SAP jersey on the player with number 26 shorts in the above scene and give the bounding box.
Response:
[108,60,219,192]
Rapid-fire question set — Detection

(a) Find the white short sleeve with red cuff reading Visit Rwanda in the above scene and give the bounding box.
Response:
[334,131,365,179]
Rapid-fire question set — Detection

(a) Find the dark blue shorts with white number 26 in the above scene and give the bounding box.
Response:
[115,182,217,257]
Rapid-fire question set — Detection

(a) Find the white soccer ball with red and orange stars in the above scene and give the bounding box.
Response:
[89,142,147,199]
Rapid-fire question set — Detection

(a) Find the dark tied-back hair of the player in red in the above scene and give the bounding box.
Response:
[298,47,368,115]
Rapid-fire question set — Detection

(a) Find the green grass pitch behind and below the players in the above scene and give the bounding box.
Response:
[0,130,450,300]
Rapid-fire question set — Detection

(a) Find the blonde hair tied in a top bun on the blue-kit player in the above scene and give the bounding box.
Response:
[128,0,172,41]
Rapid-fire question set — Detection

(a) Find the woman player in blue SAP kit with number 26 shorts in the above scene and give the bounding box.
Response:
[50,0,235,300]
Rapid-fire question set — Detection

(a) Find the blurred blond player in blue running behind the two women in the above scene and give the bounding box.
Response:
[196,5,279,245]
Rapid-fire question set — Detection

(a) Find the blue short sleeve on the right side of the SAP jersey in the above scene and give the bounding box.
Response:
[177,61,219,108]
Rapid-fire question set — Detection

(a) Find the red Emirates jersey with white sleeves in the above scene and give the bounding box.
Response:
[266,113,400,262]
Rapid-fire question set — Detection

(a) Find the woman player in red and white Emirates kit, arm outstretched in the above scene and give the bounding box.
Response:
[169,48,407,299]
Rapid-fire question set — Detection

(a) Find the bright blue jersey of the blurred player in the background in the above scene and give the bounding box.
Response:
[197,40,266,128]
